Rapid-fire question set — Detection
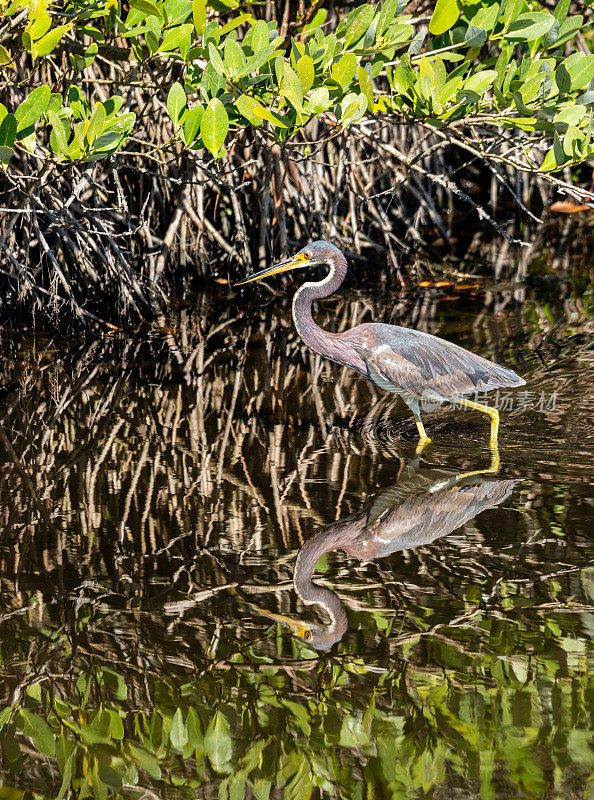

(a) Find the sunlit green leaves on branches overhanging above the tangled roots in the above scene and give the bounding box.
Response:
[0,0,594,170]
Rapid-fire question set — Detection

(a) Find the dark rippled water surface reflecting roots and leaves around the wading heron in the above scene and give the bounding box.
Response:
[0,272,594,800]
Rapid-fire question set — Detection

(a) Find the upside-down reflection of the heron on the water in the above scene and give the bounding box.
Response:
[243,457,520,650]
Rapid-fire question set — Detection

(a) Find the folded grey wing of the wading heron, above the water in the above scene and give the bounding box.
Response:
[350,323,525,397]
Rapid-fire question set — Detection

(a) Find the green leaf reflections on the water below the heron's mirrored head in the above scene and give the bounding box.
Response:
[0,608,594,800]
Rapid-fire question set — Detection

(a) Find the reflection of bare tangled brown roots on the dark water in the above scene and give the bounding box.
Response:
[0,280,588,712]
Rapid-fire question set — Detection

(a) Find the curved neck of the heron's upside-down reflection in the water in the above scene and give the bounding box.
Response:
[293,526,348,632]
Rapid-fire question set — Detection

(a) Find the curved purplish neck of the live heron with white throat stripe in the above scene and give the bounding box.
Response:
[293,253,352,364]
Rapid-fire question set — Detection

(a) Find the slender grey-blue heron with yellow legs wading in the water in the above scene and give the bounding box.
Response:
[237,241,525,450]
